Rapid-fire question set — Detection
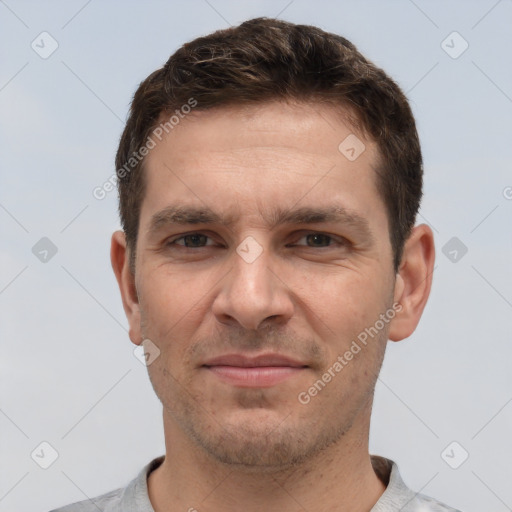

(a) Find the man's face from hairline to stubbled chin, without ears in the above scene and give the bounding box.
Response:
[131,102,395,468]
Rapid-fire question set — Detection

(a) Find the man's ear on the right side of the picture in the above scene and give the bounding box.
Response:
[388,224,435,341]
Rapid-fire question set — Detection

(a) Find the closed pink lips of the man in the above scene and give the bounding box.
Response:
[202,354,308,388]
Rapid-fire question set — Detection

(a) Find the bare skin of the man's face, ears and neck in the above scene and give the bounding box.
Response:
[111,102,434,512]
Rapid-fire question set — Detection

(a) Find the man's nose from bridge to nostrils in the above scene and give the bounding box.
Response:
[212,242,294,330]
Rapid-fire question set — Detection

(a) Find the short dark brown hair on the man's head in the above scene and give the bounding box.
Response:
[116,18,423,272]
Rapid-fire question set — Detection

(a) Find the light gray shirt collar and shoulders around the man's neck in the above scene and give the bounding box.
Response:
[51,455,460,512]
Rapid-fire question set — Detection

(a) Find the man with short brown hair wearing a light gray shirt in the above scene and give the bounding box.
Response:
[51,18,460,512]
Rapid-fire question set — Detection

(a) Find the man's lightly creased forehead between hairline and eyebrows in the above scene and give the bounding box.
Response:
[141,102,384,232]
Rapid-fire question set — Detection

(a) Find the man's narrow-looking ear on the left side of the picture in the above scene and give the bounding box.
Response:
[110,231,142,345]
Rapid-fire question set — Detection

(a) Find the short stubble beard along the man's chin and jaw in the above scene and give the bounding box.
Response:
[143,308,387,473]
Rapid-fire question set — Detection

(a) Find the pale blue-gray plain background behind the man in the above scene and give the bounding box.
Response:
[0,0,512,512]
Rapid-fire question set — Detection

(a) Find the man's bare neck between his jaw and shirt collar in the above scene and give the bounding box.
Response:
[148,407,386,512]
